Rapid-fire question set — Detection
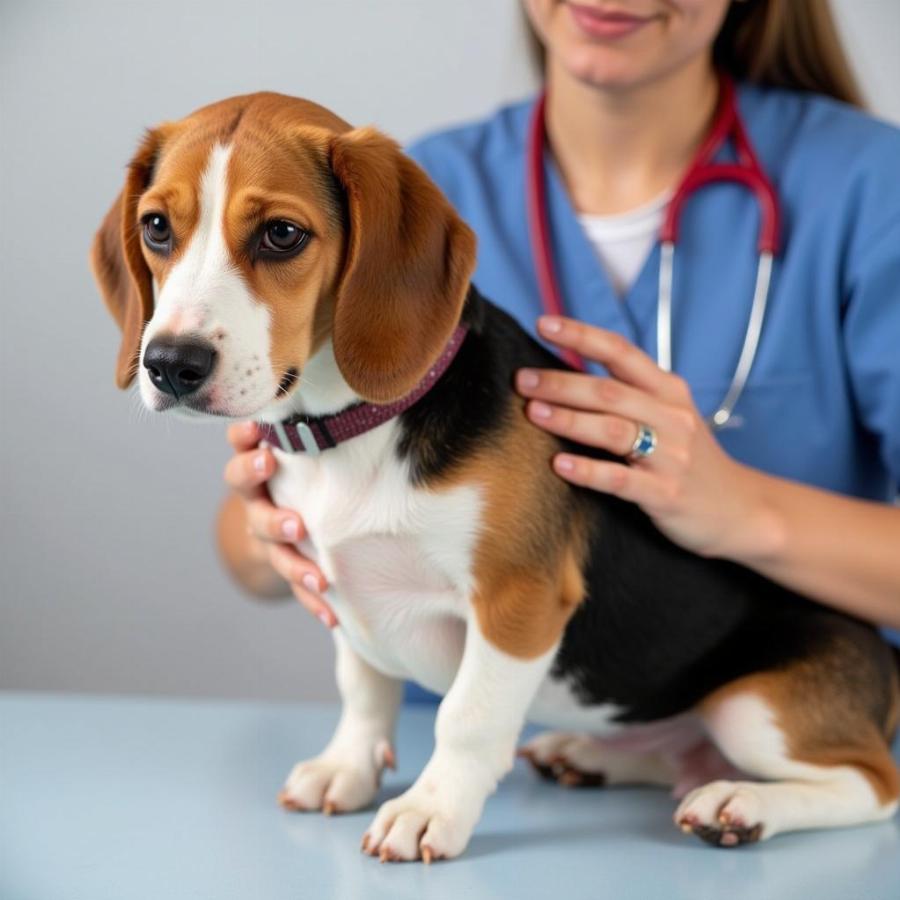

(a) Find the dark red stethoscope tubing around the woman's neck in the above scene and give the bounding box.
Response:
[525,75,781,371]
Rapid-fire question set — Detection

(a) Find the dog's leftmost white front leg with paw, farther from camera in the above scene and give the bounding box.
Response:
[279,629,402,813]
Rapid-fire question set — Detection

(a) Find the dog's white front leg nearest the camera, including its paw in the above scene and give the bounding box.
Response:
[363,615,556,862]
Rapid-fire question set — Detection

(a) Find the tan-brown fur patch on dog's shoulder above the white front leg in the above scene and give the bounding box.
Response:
[441,396,586,659]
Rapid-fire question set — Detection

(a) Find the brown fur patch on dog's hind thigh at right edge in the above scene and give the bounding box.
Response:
[700,637,900,804]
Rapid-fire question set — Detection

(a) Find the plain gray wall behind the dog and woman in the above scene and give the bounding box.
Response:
[0,0,900,698]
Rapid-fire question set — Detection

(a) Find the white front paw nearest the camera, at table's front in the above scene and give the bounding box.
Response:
[362,783,481,863]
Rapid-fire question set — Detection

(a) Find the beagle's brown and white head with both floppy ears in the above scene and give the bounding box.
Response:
[91,94,475,418]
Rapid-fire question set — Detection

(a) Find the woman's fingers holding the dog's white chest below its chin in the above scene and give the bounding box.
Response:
[225,422,337,628]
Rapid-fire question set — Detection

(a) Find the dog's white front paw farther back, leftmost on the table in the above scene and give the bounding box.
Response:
[278,741,394,815]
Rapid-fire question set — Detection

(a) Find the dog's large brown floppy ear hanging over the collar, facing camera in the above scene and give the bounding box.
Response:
[330,128,475,403]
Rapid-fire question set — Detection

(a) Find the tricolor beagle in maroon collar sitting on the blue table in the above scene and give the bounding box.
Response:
[92,93,900,862]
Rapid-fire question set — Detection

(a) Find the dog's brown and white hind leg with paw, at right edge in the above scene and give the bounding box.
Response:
[675,648,900,847]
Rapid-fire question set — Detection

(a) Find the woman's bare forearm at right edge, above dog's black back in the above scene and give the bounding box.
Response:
[726,469,900,628]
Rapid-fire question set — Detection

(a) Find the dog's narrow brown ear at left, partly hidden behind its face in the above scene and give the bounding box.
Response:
[91,130,169,388]
